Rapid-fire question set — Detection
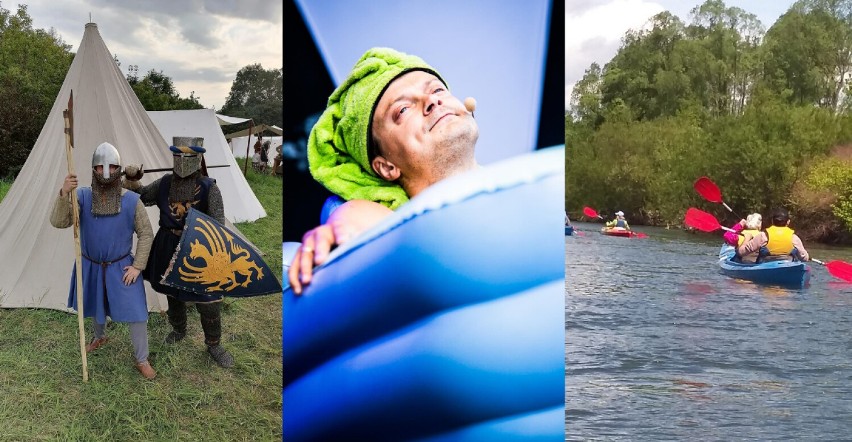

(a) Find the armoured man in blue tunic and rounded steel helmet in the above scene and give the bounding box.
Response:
[50,143,157,379]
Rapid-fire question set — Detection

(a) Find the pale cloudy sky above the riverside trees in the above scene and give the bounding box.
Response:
[565,0,793,109]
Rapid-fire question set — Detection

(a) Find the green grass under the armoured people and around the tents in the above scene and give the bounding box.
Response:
[0,167,282,441]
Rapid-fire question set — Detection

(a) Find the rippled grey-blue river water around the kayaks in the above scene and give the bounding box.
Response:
[565,223,852,441]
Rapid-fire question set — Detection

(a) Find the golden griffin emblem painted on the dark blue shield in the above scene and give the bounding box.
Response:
[178,219,263,292]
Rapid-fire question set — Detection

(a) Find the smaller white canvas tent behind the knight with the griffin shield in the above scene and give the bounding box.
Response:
[145,109,266,223]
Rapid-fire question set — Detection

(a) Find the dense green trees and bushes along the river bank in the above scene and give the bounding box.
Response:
[565,0,852,243]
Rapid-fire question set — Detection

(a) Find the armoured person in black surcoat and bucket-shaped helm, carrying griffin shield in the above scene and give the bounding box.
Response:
[125,137,234,368]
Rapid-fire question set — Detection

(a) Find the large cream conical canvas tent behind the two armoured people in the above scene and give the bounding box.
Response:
[0,23,172,311]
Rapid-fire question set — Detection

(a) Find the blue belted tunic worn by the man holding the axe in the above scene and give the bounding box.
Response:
[68,187,148,324]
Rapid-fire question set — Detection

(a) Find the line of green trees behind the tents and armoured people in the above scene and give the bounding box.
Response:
[0,3,284,178]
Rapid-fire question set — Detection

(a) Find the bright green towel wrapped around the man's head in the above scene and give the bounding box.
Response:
[308,48,446,209]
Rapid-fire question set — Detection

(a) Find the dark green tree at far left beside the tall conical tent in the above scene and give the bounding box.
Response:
[0,5,74,177]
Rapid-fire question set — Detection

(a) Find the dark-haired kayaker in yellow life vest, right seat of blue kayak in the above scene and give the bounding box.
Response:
[737,208,810,261]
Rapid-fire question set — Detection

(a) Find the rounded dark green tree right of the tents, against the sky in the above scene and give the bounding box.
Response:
[220,64,284,127]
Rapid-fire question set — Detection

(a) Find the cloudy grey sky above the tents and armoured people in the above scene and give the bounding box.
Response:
[17,0,283,109]
